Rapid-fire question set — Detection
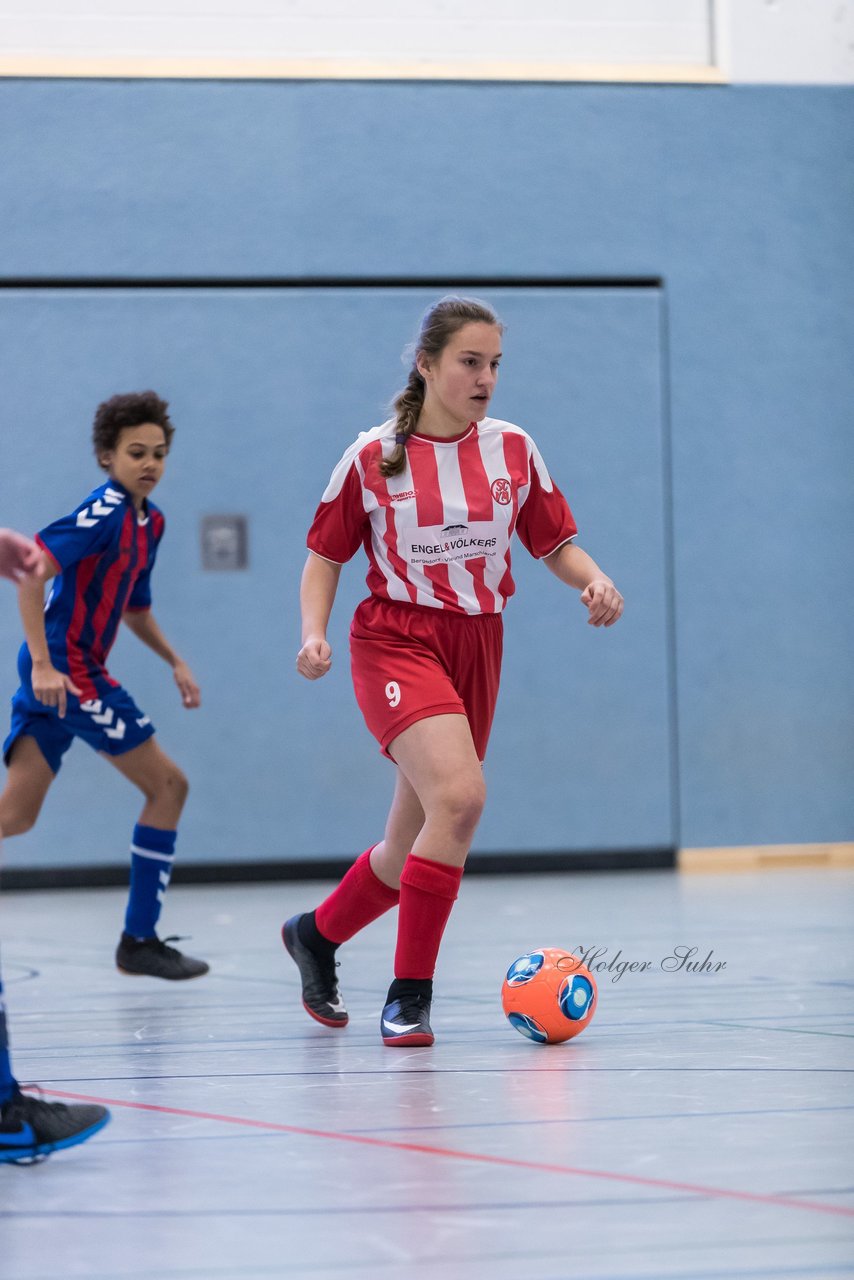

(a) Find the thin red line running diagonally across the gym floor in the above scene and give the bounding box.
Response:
[42,1085,854,1217]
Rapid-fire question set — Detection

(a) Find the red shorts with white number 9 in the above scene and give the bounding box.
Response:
[350,595,503,760]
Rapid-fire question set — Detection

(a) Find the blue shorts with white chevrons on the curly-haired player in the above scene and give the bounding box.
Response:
[3,646,154,773]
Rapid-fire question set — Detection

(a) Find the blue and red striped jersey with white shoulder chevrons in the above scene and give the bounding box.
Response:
[36,480,165,699]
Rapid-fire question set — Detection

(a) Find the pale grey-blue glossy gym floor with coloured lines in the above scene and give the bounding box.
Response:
[0,870,854,1280]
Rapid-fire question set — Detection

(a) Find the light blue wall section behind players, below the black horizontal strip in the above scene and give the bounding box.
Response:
[0,287,673,861]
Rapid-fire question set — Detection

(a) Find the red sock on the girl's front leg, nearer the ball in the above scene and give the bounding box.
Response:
[394,854,462,978]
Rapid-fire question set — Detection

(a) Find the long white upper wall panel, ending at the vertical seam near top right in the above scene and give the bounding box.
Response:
[0,0,713,78]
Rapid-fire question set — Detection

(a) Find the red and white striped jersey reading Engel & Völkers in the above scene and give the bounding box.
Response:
[307,417,576,613]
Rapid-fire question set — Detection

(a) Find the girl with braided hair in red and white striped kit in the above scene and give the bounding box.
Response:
[283,297,622,1046]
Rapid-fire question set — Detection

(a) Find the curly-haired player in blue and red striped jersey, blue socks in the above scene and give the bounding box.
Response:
[0,392,209,980]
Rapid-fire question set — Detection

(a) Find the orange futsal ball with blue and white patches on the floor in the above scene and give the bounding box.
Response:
[501,947,597,1044]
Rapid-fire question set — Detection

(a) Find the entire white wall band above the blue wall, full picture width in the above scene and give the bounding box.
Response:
[0,0,854,84]
